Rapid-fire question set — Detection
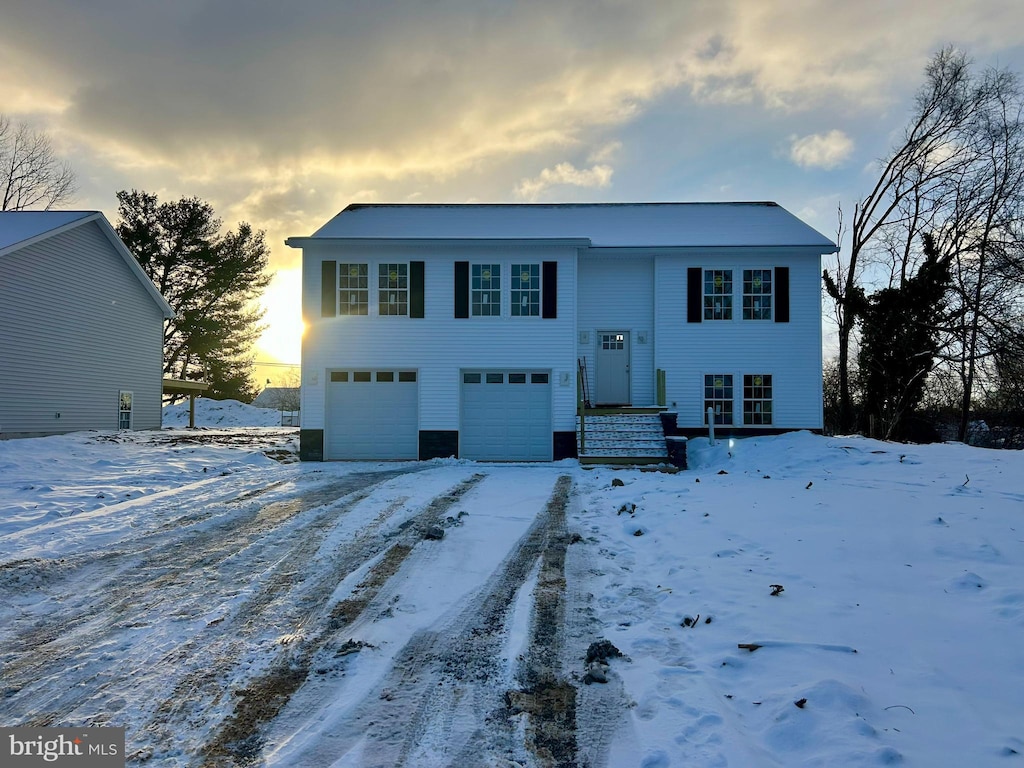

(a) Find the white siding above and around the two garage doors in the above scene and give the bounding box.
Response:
[302,243,577,432]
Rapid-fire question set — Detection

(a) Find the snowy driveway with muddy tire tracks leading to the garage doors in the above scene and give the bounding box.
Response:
[0,430,598,766]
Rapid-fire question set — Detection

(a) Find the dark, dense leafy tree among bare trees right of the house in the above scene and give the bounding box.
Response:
[858,234,950,439]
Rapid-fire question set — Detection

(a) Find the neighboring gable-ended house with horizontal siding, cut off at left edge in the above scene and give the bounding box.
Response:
[0,211,174,437]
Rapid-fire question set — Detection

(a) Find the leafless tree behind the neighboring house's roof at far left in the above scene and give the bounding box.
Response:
[0,115,76,211]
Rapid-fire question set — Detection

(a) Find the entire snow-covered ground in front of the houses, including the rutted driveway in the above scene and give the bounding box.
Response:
[0,409,1024,768]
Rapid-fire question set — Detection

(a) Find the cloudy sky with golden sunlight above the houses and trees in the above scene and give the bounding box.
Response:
[0,0,1024,372]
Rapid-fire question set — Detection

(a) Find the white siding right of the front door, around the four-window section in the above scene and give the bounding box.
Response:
[654,249,822,429]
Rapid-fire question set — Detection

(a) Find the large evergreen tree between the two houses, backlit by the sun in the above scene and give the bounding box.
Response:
[117,189,270,402]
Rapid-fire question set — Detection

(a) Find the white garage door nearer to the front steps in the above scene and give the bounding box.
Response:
[459,371,551,461]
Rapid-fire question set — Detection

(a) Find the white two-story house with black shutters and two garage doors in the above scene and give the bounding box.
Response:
[287,203,836,461]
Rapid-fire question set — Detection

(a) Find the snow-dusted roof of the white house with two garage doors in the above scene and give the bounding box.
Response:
[288,203,836,253]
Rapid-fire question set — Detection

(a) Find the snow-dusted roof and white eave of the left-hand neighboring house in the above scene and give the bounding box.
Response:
[0,211,174,317]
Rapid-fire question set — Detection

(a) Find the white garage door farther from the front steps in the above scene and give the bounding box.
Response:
[324,369,420,459]
